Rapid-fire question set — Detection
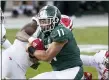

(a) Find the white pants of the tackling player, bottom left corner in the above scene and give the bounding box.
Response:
[0,51,26,79]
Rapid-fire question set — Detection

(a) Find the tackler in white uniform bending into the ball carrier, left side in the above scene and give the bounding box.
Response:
[0,15,38,79]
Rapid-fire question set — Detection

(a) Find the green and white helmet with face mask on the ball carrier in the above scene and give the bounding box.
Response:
[37,5,61,32]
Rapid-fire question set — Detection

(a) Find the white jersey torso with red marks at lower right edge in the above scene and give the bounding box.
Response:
[94,50,109,79]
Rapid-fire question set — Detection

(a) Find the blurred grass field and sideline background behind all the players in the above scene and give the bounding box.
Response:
[0,0,109,79]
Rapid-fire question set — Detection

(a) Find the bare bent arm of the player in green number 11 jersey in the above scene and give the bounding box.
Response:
[33,40,68,61]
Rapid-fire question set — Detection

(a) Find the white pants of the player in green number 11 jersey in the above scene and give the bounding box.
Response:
[31,67,80,79]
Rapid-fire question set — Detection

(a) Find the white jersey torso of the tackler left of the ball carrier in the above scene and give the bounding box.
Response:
[3,39,33,73]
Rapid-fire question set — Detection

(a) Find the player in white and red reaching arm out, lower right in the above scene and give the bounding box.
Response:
[80,50,109,80]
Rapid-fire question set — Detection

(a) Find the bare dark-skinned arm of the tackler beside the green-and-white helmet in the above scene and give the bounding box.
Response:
[16,21,38,42]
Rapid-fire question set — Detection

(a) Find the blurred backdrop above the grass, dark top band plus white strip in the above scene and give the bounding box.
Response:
[0,0,109,28]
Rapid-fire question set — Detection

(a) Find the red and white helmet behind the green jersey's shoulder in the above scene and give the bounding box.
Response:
[60,15,73,31]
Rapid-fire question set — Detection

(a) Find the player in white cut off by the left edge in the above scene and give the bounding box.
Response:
[0,8,11,49]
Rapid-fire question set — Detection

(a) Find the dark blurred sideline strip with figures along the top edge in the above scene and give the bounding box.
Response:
[1,0,109,17]
